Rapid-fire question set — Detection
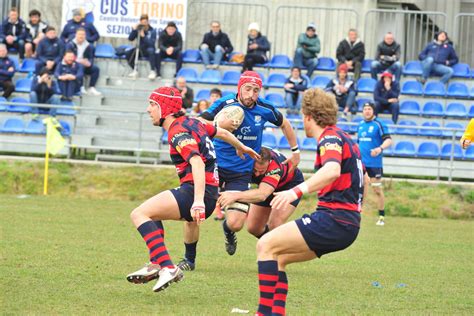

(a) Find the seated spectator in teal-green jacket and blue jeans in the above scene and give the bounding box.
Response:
[293,23,321,78]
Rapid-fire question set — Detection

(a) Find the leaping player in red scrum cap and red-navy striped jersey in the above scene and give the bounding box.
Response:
[127,87,260,292]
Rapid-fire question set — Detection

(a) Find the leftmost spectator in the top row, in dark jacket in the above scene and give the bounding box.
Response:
[0,8,28,59]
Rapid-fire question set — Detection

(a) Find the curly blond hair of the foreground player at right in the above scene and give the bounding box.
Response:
[301,88,338,128]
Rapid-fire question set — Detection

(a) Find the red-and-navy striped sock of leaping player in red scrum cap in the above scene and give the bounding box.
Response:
[138,221,174,268]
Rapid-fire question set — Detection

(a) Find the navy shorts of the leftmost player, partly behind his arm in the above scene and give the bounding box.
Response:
[170,183,218,222]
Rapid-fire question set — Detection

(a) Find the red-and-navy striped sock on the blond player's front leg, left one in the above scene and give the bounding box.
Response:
[257,260,278,315]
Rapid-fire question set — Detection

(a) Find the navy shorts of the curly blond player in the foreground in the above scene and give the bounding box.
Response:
[295,211,360,258]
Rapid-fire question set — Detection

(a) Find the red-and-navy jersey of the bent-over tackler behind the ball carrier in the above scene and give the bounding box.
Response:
[252,148,303,190]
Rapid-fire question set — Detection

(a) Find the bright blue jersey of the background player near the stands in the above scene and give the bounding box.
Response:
[357,118,390,168]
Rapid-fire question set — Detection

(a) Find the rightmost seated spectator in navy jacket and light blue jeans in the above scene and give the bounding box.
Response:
[418,31,458,84]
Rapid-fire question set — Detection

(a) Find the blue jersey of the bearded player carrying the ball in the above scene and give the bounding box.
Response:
[201,94,283,173]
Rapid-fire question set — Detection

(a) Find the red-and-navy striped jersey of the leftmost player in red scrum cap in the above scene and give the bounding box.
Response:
[168,116,219,186]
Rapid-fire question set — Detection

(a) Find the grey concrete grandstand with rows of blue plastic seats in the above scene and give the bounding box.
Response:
[0,1,474,179]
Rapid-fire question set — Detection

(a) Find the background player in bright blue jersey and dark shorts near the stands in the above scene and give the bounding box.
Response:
[357,102,392,226]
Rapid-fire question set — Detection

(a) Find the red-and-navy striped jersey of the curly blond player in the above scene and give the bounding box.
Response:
[315,126,364,213]
